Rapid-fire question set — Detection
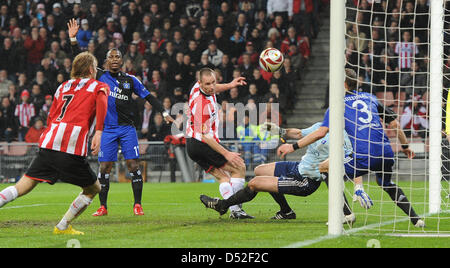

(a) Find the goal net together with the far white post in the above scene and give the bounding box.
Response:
[330,0,450,235]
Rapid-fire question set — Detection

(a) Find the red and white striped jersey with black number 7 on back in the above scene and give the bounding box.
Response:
[39,79,109,156]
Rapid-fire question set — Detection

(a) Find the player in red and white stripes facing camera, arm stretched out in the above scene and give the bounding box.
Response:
[186,68,253,219]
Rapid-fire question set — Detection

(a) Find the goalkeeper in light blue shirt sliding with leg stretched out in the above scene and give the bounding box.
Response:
[200,122,355,223]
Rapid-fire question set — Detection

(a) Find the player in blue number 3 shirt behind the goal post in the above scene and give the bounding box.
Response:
[278,69,425,227]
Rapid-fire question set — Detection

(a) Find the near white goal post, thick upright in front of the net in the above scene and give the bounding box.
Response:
[328,0,345,235]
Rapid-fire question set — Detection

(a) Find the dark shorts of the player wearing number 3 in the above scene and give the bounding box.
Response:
[344,156,395,186]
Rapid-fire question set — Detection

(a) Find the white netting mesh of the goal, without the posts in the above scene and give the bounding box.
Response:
[345,0,450,233]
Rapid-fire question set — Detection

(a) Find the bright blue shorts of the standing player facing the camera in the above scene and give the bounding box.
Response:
[98,126,139,162]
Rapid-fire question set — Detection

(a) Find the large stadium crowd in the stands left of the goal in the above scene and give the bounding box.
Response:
[0,0,328,147]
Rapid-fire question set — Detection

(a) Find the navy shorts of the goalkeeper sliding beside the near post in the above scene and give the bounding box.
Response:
[274,161,320,196]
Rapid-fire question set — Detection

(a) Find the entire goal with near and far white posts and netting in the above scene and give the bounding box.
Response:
[328,0,450,236]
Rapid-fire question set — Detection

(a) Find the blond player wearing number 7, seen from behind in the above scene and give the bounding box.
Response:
[0,52,109,235]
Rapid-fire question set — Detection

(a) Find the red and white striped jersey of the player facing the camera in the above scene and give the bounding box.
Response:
[186,83,220,143]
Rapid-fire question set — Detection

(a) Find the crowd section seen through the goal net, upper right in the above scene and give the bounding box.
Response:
[346,0,432,141]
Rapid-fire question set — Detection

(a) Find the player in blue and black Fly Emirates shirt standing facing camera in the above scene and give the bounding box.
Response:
[67,19,173,216]
